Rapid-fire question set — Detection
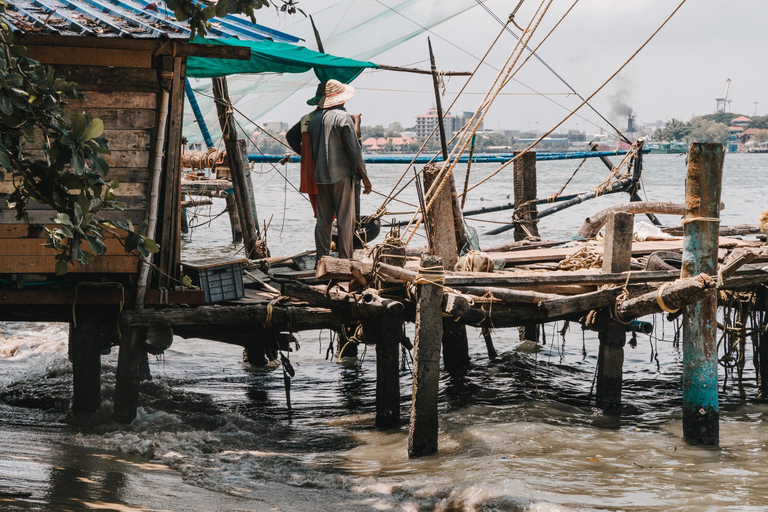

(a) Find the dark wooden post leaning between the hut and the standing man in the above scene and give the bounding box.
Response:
[213,77,259,259]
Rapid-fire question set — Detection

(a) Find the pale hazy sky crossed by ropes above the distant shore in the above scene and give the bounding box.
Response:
[249,0,768,133]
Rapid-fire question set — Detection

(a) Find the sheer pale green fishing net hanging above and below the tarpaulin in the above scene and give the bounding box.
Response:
[184,0,488,142]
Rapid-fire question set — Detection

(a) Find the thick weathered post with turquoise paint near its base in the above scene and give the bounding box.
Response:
[681,142,724,445]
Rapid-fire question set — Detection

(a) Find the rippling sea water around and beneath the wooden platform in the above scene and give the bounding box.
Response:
[0,154,768,511]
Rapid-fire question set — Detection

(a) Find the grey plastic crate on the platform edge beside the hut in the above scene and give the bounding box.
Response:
[182,259,247,304]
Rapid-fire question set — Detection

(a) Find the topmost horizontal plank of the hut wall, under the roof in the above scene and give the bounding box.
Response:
[27,45,152,68]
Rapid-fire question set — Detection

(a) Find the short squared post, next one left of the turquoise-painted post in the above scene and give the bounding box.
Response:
[595,212,634,414]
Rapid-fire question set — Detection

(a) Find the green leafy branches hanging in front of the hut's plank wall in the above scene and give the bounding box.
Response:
[0,0,158,274]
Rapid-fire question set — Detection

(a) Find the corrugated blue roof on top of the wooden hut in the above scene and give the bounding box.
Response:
[3,0,300,43]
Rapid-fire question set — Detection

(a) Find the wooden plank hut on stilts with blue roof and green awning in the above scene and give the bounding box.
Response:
[0,0,378,420]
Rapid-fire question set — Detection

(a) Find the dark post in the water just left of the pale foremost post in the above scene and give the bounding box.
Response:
[363,309,403,428]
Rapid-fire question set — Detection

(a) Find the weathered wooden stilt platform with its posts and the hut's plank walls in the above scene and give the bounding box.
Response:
[0,1,768,456]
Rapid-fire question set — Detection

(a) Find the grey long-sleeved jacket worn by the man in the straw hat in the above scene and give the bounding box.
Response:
[309,106,365,185]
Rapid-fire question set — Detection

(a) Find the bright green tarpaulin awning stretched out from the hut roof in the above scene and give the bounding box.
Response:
[187,36,379,83]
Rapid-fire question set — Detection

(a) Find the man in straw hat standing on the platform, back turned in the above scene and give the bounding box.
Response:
[309,80,371,260]
